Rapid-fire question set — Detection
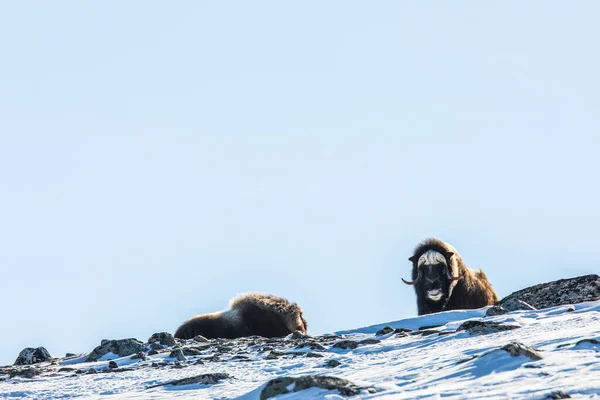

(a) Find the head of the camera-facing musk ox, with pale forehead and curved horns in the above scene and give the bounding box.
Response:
[402,249,461,311]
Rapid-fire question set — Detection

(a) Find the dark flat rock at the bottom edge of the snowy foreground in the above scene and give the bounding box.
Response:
[260,375,368,400]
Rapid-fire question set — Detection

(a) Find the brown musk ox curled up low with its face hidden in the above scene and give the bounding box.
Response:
[175,293,307,339]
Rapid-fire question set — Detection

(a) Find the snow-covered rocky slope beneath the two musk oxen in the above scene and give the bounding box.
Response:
[0,301,600,400]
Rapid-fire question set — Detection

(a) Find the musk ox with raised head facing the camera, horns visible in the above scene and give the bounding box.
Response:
[402,238,498,315]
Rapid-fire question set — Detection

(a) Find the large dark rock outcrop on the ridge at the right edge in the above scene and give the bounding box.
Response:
[496,274,600,309]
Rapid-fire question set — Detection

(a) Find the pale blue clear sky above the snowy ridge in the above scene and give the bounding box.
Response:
[0,1,600,365]
